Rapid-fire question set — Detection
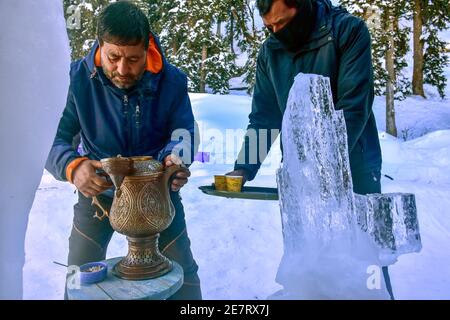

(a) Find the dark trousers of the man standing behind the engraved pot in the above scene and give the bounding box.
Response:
[68,192,202,300]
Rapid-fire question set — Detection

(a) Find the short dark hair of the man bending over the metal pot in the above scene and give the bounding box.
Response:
[97,1,150,50]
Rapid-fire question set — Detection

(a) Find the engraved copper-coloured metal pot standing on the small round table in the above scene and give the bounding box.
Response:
[101,156,188,280]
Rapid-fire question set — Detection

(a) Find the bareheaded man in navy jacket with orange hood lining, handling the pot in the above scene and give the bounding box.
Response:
[46,1,201,299]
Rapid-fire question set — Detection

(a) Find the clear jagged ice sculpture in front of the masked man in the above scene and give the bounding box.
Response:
[277,74,420,299]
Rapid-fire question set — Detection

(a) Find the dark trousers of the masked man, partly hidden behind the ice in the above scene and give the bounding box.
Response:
[352,170,394,300]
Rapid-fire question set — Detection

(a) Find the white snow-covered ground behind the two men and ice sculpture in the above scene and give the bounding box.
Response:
[24,82,450,299]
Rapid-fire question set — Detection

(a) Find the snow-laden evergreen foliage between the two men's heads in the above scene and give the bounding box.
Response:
[151,0,267,93]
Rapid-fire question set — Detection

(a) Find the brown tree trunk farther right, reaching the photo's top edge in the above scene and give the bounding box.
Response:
[412,0,425,97]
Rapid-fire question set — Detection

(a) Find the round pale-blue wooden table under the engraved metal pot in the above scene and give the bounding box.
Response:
[67,257,183,300]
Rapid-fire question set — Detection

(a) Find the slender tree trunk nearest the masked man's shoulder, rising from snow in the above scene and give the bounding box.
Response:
[386,15,398,137]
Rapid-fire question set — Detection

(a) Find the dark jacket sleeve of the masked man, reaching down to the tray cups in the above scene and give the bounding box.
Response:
[234,46,283,181]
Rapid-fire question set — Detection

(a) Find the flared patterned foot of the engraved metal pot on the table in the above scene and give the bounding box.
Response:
[112,234,173,280]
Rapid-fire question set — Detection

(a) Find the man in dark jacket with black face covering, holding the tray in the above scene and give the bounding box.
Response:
[228,0,393,299]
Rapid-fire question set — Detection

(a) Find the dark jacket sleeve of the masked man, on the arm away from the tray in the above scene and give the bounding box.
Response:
[335,16,374,153]
